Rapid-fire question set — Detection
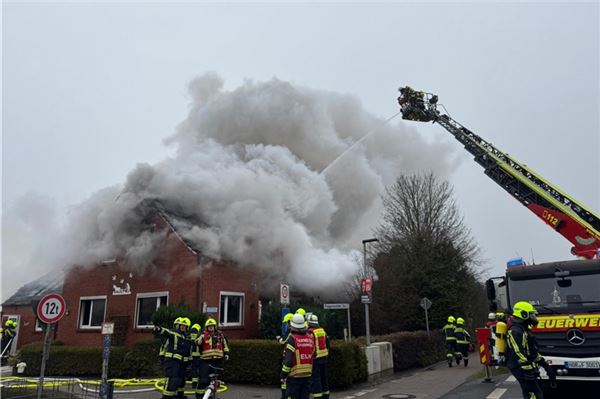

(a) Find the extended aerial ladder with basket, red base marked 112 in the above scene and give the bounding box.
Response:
[398,86,600,259]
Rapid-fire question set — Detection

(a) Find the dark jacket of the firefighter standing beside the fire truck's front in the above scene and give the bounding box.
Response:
[506,318,543,372]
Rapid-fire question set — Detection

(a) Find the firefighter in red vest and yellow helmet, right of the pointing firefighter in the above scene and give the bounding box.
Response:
[196,318,229,398]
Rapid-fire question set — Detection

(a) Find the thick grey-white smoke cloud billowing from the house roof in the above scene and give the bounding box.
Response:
[5,73,453,300]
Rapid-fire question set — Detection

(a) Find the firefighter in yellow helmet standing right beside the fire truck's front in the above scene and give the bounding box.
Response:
[506,301,556,399]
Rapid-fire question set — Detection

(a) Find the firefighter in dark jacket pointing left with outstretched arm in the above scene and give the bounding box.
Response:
[154,317,191,399]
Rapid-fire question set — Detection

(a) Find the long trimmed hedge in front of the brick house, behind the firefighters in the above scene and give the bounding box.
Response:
[17,339,367,388]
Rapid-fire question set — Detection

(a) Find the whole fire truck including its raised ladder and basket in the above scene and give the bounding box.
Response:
[398,86,600,383]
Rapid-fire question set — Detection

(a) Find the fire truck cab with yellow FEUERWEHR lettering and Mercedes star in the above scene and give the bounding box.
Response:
[488,259,600,382]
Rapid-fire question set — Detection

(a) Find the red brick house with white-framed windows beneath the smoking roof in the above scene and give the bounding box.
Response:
[2,201,259,347]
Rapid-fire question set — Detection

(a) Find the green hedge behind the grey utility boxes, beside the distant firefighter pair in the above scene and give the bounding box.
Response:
[356,331,446,371]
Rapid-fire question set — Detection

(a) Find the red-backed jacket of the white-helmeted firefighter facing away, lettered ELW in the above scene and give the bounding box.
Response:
[281,329,315,379]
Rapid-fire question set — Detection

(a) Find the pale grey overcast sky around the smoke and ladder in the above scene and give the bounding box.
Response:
[2,2,600,296]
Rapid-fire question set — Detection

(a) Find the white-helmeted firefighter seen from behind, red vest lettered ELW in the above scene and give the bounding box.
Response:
[281,313,315,399]
